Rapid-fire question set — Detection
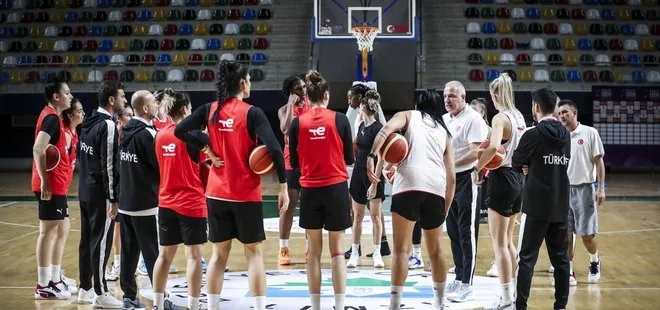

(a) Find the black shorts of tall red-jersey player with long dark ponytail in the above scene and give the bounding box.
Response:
[206,198,266,244]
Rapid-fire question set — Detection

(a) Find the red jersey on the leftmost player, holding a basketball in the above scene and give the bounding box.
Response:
[32,106,71,196]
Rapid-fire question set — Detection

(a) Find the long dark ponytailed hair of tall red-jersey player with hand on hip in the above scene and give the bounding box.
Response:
[211,60,248,123]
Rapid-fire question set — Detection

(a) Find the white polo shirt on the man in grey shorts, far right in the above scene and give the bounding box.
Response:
[568,123,605,185]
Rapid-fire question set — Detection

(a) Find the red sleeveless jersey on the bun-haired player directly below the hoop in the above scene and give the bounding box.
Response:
[297,108,348,187]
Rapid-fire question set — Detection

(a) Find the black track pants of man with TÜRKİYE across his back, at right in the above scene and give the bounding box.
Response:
[516,213,569,310]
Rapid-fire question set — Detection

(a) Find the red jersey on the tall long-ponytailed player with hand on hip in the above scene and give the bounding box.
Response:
[206,98,262,202]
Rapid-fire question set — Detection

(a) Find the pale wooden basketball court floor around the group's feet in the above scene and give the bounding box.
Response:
[0,174,660,310]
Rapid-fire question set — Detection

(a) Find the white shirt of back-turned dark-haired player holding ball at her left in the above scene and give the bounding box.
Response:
[392,111,447,197]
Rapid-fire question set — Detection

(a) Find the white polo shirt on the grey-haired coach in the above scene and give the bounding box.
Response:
[442,105,489,172]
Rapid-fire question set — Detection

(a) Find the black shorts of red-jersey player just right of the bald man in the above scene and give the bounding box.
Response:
[158,208,207,246]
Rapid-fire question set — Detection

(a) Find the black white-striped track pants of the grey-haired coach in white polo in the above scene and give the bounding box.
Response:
[447,170,479,284]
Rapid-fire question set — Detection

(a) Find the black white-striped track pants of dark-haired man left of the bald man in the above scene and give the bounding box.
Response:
[78,199,115,295]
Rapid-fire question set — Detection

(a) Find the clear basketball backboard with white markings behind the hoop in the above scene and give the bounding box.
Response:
[312,0,418,40]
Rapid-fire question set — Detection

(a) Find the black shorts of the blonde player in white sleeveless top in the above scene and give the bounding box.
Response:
[485,167,523,217]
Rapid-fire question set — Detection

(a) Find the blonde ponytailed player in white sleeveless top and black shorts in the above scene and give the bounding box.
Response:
[472,73,527,310]
